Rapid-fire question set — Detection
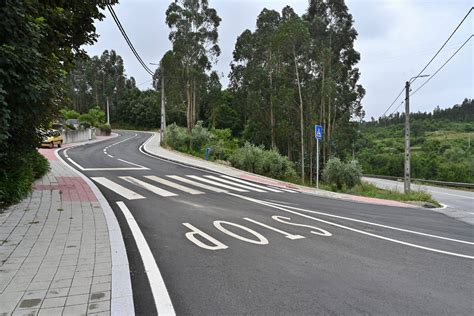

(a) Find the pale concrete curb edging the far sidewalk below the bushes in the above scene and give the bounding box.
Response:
[140,132,421,209]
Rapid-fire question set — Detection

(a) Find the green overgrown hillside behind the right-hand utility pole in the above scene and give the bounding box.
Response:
[355,99,474,183]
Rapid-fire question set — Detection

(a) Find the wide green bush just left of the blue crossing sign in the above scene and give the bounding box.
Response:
[229,142,296,179]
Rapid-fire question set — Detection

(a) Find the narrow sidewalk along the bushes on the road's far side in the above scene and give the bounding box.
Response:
[143,133,417,208]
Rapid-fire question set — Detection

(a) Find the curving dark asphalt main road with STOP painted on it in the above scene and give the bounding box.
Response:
[61,132,474,315]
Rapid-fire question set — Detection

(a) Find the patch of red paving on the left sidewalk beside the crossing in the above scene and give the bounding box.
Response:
[34,177,97,202]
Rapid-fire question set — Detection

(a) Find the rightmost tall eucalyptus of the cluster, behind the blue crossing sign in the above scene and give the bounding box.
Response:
[303,0,365,162]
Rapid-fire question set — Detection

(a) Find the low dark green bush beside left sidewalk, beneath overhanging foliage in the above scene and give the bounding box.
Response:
[0,150,49,207]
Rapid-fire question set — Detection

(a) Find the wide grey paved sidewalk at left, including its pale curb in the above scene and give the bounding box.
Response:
[0,141,133,315]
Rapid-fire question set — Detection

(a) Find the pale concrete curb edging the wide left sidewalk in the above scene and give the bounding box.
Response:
[54,133,135,316]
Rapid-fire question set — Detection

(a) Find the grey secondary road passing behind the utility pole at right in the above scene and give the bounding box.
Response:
[364,178,474,214]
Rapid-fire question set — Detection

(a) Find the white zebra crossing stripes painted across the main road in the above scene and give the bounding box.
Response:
[92,175,298,200]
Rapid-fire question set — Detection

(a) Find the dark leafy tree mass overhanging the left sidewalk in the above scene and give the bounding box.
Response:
[0,0,103,205]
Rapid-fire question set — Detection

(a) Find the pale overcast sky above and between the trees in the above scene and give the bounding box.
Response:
[86,0,474,120]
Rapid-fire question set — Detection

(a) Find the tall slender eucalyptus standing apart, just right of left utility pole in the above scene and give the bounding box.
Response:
[166,0,221,130]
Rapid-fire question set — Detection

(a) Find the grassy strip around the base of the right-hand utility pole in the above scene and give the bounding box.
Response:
[320,181,441,207]
